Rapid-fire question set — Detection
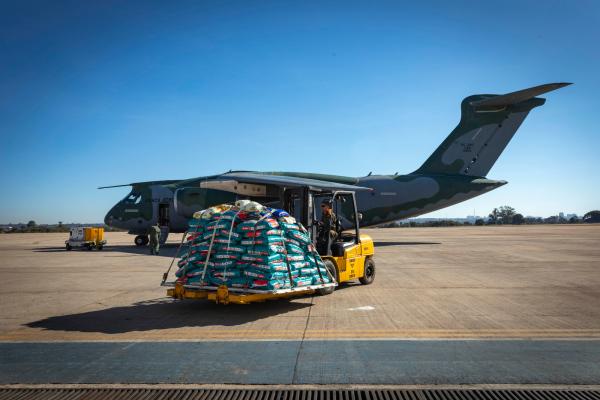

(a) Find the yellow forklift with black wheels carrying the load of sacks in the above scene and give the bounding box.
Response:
[281,186,375,295]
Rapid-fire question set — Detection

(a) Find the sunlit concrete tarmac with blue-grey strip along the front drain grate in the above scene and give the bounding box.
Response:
[0,225,600,385]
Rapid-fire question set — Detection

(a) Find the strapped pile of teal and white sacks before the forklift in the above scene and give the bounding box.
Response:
[175,200,332,291]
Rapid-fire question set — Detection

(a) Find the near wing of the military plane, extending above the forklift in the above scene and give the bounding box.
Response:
[218,172,372,192]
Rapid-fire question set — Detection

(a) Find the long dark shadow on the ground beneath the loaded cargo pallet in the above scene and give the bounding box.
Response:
[25,298,311,334]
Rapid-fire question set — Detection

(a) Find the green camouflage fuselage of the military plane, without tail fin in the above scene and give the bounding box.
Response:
[105,172,506,235]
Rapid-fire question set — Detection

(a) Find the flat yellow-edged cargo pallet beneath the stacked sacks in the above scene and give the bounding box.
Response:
[162,282,337,304]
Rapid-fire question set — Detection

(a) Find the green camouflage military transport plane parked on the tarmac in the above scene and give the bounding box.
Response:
[100,83,570,246]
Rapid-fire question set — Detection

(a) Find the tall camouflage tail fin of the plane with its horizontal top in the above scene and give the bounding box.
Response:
[414,83,570,176]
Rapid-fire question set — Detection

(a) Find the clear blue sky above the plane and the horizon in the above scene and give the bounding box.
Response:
[0,1,600,223]
